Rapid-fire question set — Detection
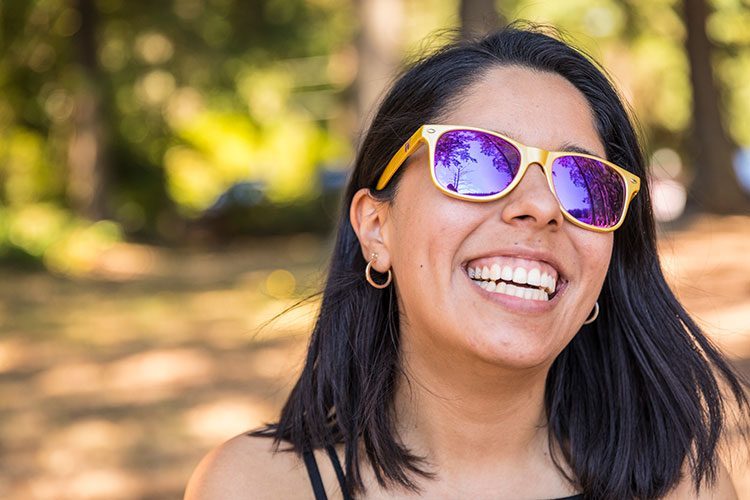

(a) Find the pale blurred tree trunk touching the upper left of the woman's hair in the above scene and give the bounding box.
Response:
[355,0,404,136]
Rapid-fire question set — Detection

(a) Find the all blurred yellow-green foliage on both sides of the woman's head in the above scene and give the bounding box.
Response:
[0,0,750,272]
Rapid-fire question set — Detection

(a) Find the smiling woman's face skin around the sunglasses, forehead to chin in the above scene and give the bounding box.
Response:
[382,67,613,368]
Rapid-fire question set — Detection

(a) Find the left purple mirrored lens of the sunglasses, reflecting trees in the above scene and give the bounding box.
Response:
[435,130,521,196]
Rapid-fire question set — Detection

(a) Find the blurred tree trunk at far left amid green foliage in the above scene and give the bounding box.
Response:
[68,0,109,220]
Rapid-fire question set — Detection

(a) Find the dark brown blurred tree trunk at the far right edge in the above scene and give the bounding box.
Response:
[683,0,750,213]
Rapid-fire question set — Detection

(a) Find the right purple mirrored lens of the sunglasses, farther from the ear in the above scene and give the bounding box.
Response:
[552,156,625,228]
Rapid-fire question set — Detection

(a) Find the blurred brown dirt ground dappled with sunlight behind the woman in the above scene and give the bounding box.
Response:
[0,217,750,500]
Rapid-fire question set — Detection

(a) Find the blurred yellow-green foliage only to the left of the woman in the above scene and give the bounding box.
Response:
[0,0,354,274]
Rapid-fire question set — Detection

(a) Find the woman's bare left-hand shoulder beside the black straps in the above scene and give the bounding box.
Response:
[185,434,311,500]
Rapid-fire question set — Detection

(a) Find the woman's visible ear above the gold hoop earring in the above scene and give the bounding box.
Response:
[349,188,391,273]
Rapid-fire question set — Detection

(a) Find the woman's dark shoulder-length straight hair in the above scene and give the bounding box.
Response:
[255,24,748,498]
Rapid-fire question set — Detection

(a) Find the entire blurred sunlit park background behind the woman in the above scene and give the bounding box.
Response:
[0,0,750,499]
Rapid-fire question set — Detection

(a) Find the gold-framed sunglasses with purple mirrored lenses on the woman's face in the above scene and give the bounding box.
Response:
[375,125,641,232]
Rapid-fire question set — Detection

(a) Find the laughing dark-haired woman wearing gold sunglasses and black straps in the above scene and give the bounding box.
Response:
[187,26,748,500]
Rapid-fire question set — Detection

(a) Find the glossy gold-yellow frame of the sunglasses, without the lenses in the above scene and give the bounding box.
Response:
[375,124,641,233]
